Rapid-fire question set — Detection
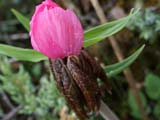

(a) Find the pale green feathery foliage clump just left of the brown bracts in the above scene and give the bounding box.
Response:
[37,76,65,114]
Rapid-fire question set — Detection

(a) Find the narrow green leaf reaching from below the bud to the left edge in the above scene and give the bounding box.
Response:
[0,44,47,62]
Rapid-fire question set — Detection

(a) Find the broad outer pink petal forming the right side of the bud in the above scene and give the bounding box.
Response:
[49,7,84,56]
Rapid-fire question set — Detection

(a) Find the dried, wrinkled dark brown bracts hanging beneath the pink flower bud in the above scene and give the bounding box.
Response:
[50,50,111,120]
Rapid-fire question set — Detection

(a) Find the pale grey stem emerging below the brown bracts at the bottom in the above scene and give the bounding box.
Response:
[99,101,119,120]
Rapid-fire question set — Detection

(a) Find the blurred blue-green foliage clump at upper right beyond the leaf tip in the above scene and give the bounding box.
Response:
[128,9,160,43]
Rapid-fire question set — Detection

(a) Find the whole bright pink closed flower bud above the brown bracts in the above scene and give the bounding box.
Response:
[30,0,84,59]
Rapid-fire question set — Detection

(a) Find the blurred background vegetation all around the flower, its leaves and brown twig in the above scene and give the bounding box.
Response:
[0,0,160,120]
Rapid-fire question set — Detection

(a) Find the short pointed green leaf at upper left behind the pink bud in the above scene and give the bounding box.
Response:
[11,9,30,31]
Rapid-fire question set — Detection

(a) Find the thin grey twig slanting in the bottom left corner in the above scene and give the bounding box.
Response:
[2,106,22,120]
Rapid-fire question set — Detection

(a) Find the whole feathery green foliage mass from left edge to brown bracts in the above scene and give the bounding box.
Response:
[0,58,66,120]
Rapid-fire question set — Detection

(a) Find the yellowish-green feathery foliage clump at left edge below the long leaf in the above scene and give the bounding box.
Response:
[0,58,34,104]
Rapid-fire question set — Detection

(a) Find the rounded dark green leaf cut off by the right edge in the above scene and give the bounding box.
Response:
[144,73,160,100]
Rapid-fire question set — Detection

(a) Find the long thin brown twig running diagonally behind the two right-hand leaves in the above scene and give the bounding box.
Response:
[91,0,149,120]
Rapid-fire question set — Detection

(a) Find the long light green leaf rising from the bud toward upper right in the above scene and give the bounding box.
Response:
[84,9,139,47]
